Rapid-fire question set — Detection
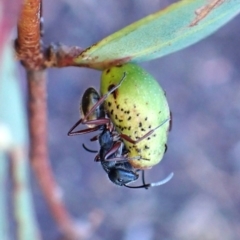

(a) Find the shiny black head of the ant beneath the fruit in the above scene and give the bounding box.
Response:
[108,167,138,186]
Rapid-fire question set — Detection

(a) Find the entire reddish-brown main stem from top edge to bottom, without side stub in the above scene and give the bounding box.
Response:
[15,0,93,239]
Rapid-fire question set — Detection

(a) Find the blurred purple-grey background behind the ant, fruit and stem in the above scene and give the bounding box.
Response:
[25,0,240,240]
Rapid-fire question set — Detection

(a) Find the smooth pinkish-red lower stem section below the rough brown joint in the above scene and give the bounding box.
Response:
[27,70,81,239]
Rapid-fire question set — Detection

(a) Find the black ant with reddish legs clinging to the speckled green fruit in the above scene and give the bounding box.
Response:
[68,73,173,189]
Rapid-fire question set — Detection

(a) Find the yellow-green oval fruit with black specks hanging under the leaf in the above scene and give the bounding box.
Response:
[100,63,170,169]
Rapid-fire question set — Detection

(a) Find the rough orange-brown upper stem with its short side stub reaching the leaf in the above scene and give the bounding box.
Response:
[15,0,83,70]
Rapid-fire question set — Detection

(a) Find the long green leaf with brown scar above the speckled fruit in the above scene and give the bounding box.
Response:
[75,0,240,70]
